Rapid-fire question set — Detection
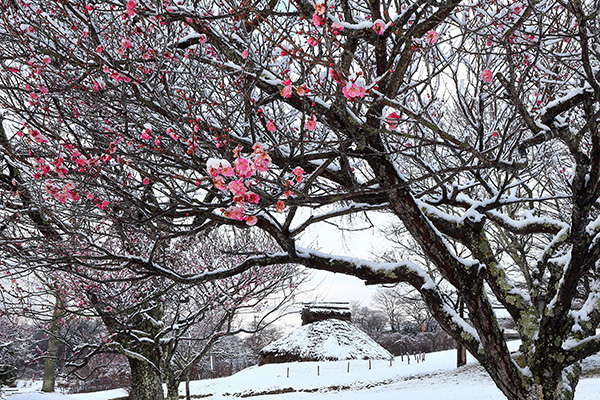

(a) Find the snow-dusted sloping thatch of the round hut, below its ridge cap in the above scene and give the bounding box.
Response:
[259,319,393,365]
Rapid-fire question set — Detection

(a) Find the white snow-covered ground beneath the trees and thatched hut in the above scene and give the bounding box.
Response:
[6,342,600,400]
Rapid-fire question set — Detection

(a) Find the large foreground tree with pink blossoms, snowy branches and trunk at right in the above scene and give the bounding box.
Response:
[0,0,600,400]
